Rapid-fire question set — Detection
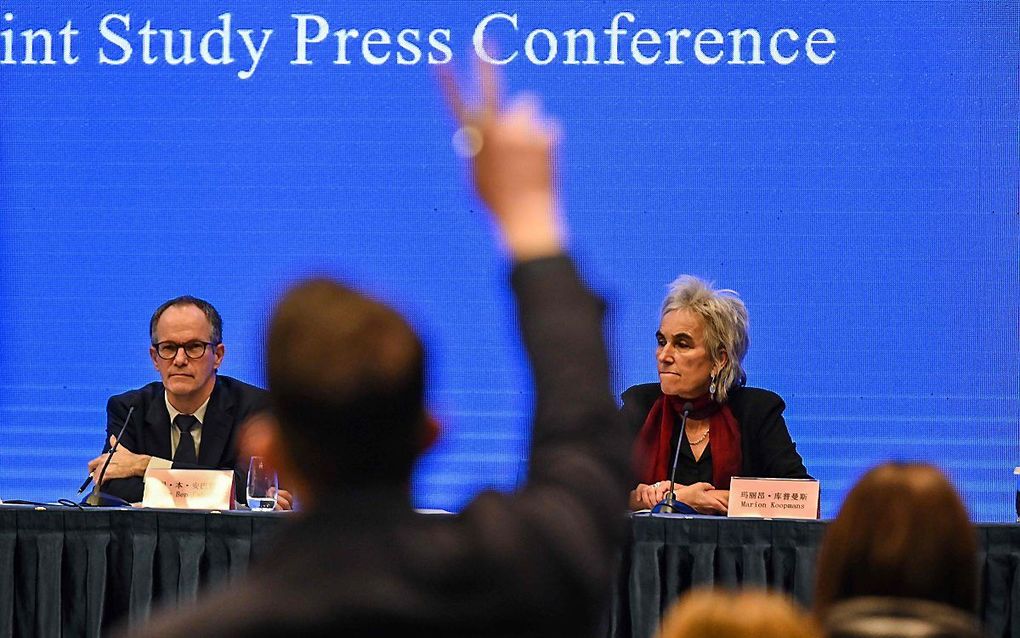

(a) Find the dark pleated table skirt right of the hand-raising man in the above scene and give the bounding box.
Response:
[609,514,1020,638]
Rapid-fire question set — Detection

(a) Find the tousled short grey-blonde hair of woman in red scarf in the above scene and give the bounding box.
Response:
[660,275,750,403]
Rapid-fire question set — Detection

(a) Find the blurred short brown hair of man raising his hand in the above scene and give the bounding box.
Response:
[266,279,425,491]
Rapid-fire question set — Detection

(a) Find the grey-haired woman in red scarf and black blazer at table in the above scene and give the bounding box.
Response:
[621,276,811,513]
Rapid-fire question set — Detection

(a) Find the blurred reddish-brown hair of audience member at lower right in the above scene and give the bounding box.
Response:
[815,463,978,617]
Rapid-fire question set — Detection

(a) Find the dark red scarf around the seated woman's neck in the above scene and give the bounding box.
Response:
[634,394,743,490]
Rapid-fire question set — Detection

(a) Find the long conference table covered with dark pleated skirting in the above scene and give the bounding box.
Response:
[0,505,1020,638]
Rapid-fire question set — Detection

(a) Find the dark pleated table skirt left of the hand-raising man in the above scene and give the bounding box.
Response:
[0,506,289,637]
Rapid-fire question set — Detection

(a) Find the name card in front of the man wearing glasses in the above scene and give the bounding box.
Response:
[142,469,234,509]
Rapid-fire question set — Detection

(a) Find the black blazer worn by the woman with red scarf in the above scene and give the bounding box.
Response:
[620,383,811,479]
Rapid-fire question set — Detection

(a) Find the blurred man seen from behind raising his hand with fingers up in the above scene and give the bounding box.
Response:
[129,67,631,638]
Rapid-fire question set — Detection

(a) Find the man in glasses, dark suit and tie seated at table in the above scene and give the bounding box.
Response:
[89,296,290,507]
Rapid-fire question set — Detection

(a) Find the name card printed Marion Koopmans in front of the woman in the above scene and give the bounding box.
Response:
[726,477,819,519]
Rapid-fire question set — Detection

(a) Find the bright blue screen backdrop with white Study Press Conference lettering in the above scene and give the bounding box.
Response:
[0,0,1020,521]
